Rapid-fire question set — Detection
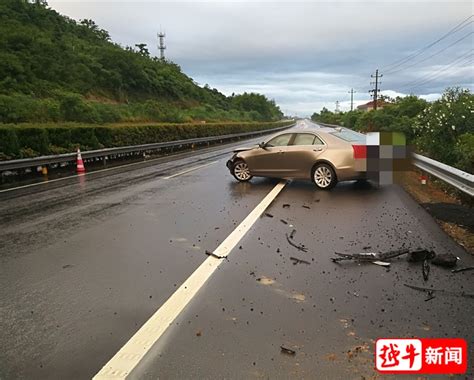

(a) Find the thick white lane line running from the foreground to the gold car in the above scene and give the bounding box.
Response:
[93,181,286,380]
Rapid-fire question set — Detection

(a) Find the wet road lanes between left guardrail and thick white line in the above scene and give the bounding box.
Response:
[0,121,308,378]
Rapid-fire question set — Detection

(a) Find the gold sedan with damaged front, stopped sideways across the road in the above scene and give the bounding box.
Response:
[227,128,365,189]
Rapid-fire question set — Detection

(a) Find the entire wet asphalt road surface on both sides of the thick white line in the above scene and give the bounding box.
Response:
[0,120,474,379]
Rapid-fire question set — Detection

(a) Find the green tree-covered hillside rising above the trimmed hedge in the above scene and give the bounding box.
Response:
[0,0,282,124]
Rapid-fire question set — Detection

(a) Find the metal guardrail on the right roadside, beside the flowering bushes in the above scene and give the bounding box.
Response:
[413,153,474,197]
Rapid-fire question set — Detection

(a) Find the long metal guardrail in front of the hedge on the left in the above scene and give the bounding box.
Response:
[0,124,295,172]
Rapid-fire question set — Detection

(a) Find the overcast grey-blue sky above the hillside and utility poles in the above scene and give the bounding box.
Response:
[48,0,474,116]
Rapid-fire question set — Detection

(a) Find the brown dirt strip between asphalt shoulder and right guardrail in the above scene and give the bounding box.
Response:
[401,170,474,255]
